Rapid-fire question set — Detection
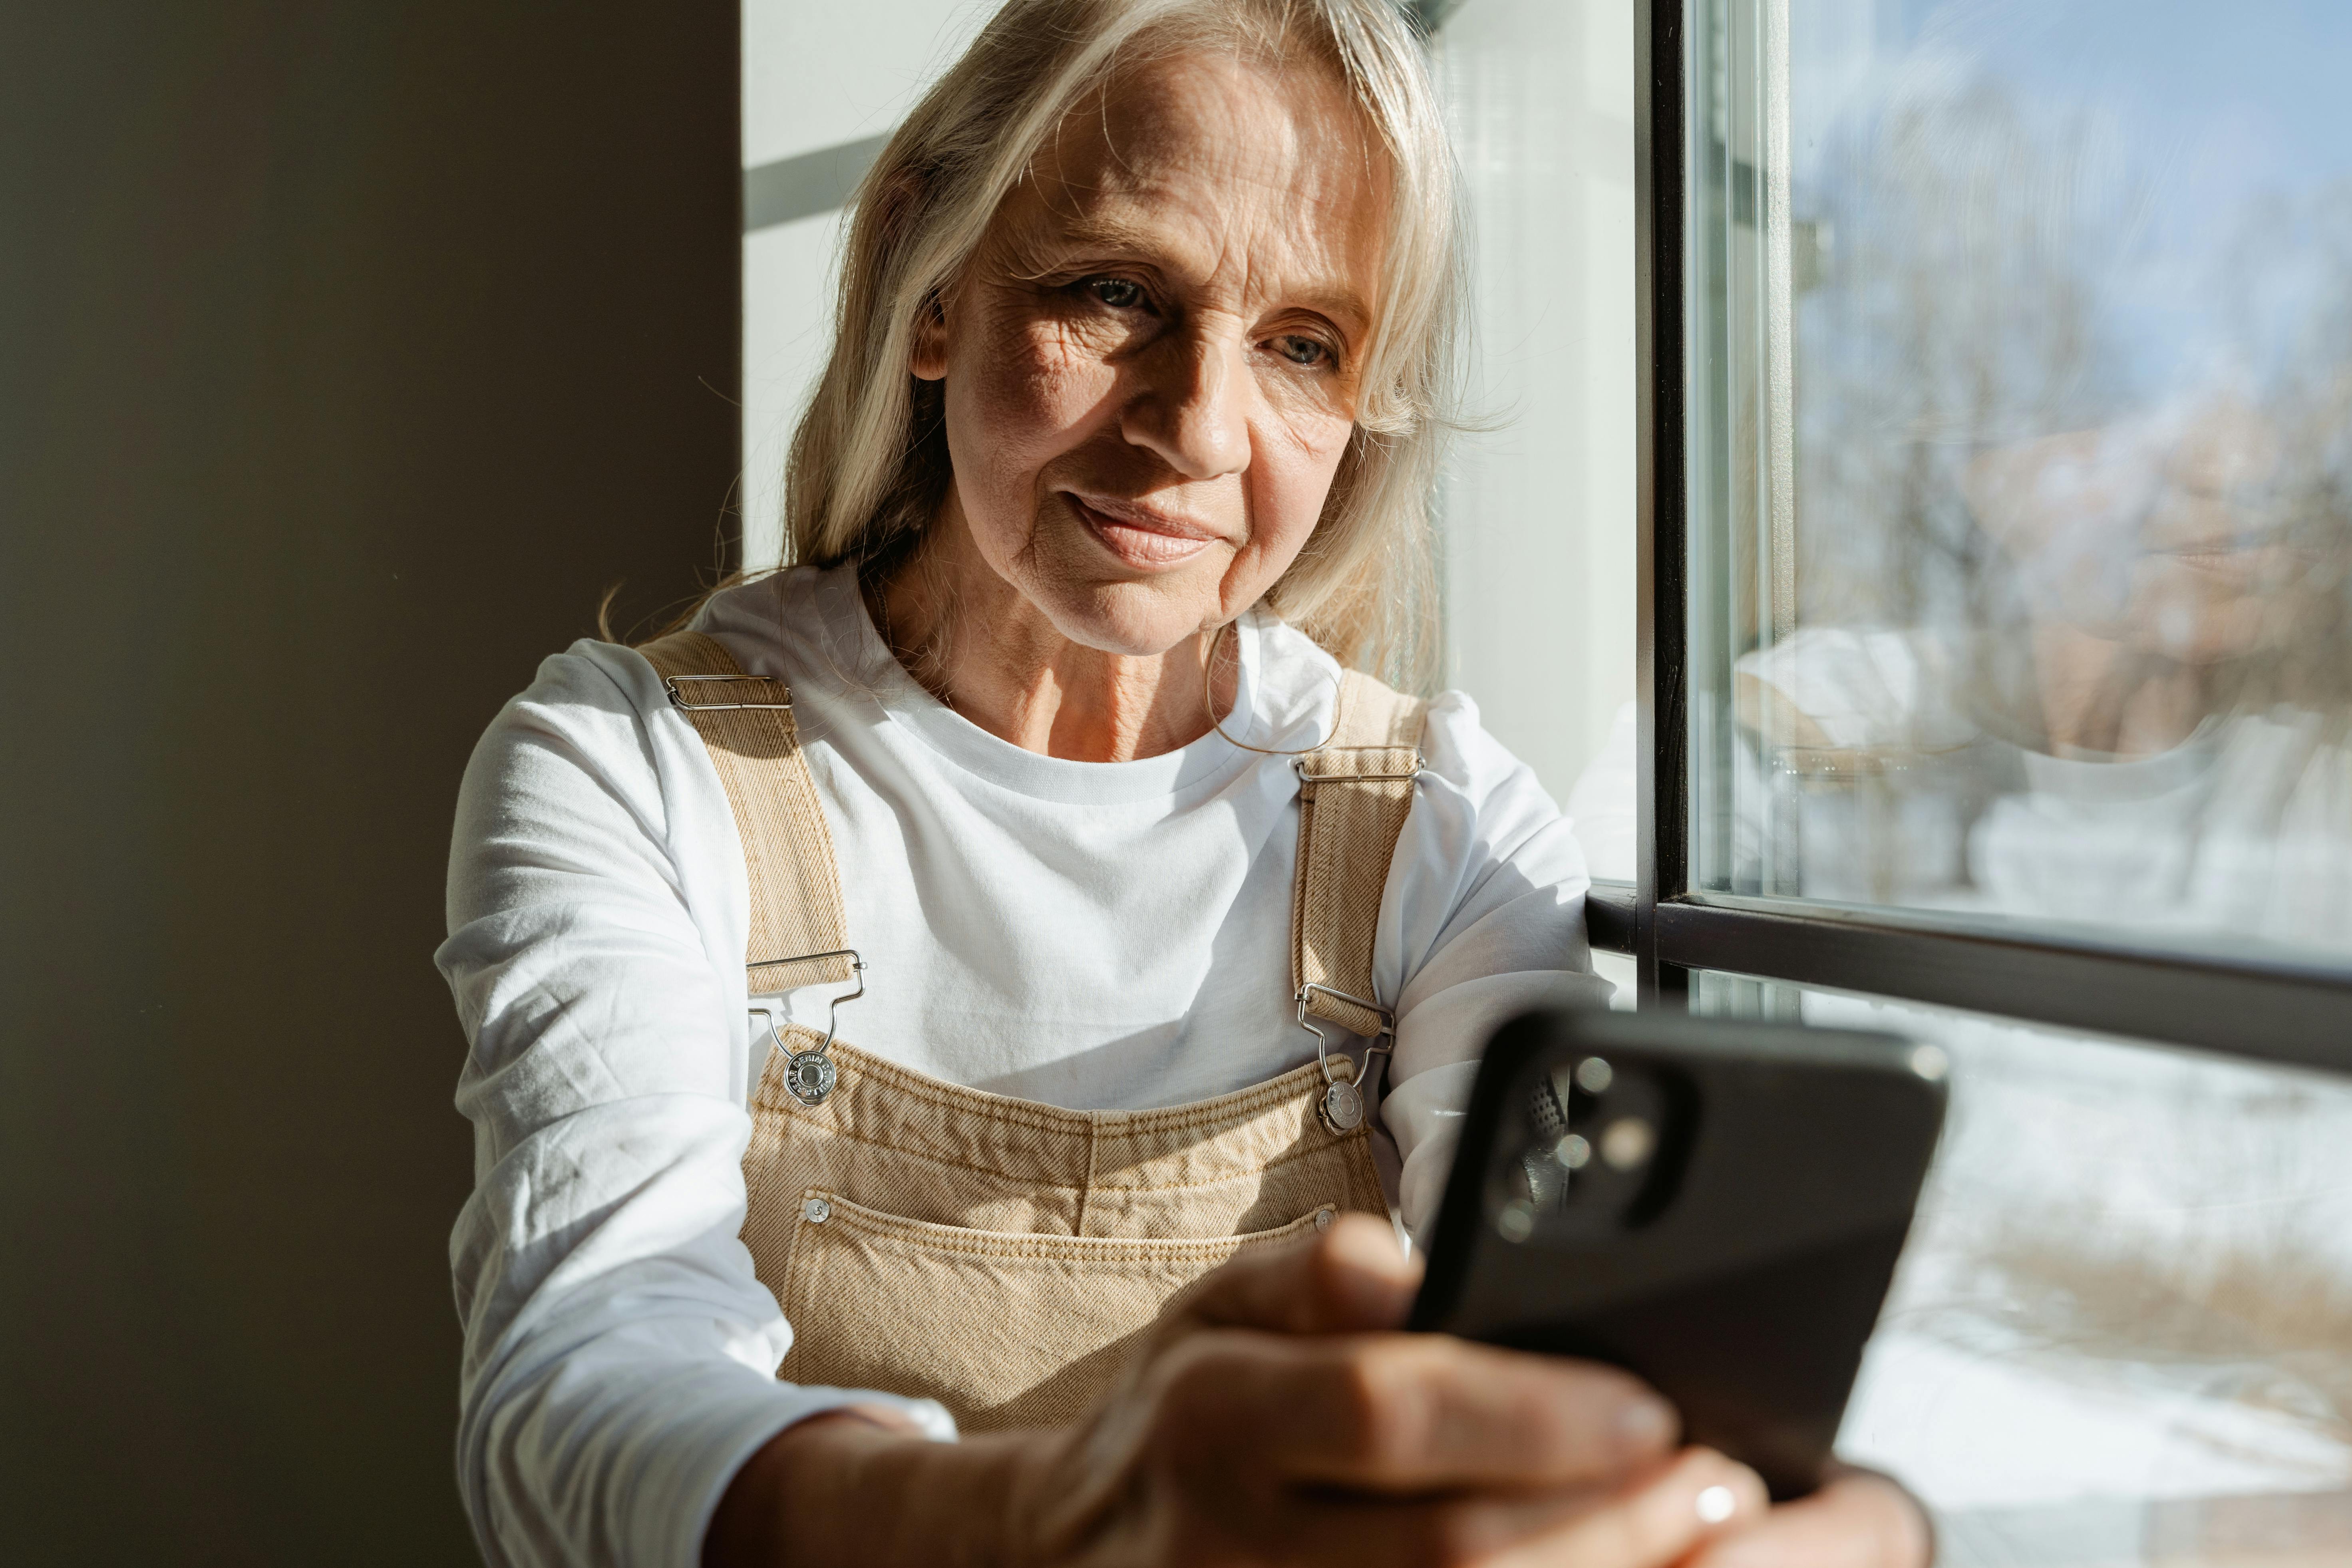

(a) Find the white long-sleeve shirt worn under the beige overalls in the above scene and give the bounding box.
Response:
[435,569,1606,1568]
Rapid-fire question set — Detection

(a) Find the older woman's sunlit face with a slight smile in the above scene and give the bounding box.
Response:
[913,56,1388,656]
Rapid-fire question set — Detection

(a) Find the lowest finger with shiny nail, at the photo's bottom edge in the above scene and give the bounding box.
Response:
[1251,1448,1766,1568]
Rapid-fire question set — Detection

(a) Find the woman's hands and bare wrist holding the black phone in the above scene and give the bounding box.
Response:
[706,1218,1926,1568]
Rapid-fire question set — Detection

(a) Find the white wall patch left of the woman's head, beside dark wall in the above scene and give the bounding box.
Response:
[741,0,995,566]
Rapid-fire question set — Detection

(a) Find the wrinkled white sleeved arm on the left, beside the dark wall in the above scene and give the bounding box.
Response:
[435,644,941,1568]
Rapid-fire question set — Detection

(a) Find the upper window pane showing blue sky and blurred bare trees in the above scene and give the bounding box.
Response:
[1689,0,2352,954]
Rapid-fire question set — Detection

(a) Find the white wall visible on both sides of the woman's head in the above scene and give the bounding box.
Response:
[743,0,1634,799]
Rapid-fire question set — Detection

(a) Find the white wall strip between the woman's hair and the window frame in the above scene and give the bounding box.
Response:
[1437,0,1634,799]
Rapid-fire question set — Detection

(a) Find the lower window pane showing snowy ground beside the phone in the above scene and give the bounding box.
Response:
[1698,973,2352,1568]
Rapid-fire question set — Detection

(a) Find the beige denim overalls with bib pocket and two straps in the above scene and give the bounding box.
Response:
[640,632,1423,1432]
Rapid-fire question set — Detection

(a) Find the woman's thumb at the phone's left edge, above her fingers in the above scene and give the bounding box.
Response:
[1185,1213,1421,1333]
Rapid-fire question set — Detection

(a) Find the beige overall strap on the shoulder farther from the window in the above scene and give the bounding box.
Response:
[637,632,851,997]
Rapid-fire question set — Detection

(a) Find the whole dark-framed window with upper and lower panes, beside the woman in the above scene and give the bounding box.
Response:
[1608,0,2352,1566]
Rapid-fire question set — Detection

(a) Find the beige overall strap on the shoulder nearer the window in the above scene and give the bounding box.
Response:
[1291,670,1428,1039]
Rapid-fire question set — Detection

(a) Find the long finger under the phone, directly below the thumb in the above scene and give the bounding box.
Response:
[1159,1331,1677,1493]
